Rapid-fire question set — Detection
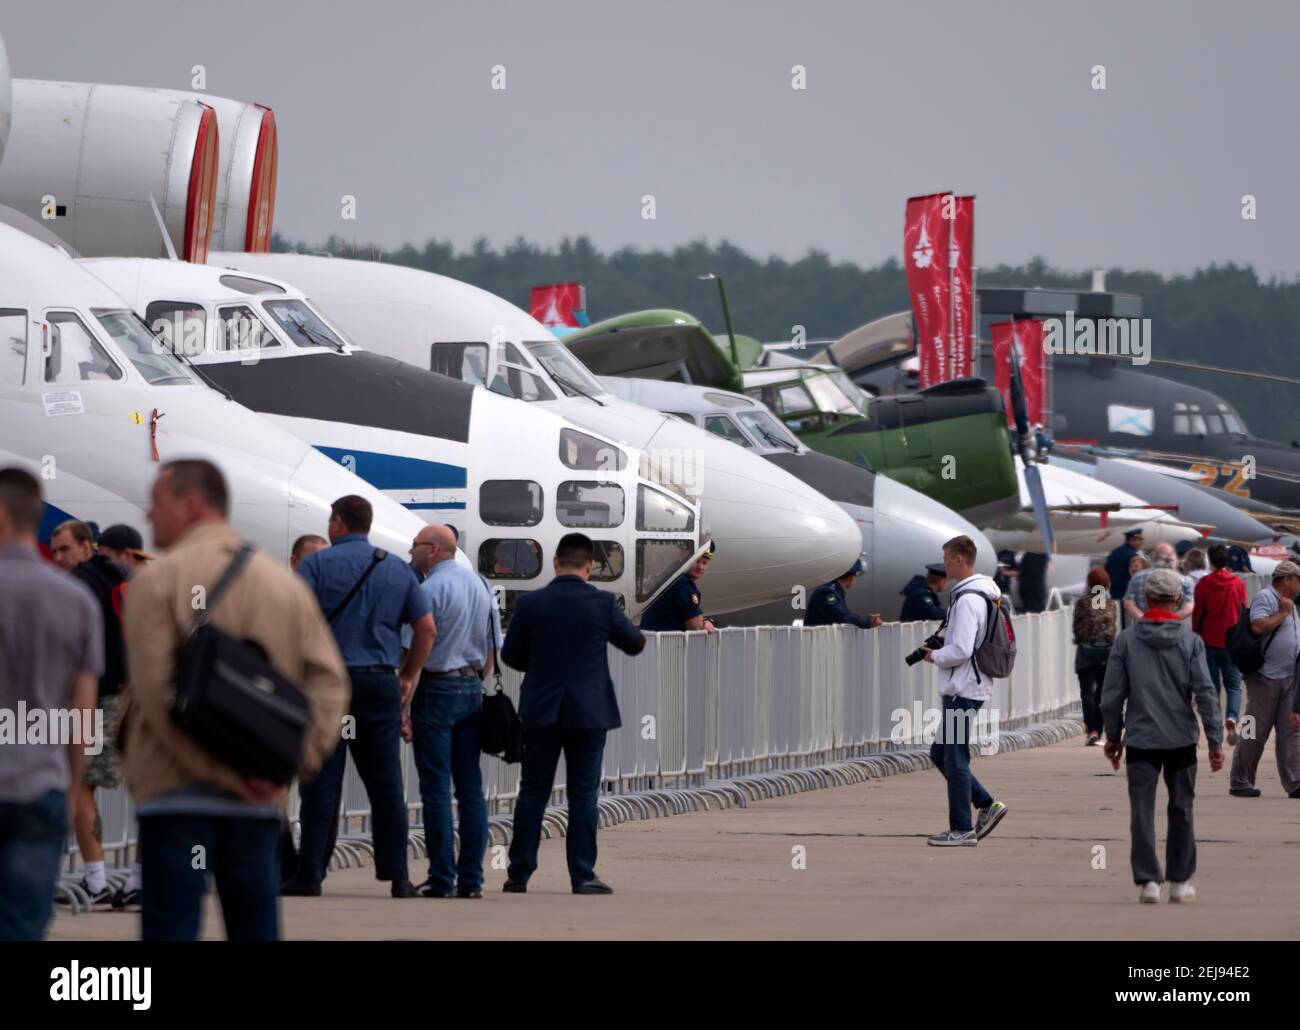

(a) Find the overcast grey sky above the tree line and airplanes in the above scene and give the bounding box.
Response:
[0,0,1300,278]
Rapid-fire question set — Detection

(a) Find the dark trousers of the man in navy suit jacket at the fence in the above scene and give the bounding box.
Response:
[507,726,606,887]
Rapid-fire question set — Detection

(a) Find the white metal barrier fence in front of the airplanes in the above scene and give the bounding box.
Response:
[69,609,1079,867]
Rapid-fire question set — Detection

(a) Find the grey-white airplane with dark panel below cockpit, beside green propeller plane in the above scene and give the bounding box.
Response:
[579,376,997,624]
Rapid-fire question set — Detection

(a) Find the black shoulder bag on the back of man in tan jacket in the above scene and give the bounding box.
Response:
[172,544,311,784]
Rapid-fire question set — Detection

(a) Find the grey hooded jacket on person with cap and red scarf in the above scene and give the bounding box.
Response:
[1101,619,1223,749]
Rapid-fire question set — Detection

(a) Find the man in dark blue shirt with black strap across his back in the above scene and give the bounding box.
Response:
[281,494,433,897]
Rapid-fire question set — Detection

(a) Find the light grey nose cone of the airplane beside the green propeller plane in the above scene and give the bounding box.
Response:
[868,476,997,619]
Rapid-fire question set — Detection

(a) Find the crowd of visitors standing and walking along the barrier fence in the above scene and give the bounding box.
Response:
[0,460,1300,940]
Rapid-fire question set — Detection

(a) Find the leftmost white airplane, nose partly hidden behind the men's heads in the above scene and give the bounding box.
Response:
[0,225,423,559]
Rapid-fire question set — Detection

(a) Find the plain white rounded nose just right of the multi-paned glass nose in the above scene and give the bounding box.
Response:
[645,420,862,614]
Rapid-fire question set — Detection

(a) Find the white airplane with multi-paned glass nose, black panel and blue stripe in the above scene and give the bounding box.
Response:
[79,258,711,615]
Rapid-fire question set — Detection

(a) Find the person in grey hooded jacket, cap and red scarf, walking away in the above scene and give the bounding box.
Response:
[1101,568,1223,904]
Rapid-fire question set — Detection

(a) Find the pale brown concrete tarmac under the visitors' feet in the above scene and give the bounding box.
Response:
[49,737,1300,942]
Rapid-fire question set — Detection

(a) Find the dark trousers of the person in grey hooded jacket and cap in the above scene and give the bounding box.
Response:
[1125,744,1196,884]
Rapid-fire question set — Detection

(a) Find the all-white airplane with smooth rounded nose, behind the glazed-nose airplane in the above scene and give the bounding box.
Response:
[202,252,862,613]
